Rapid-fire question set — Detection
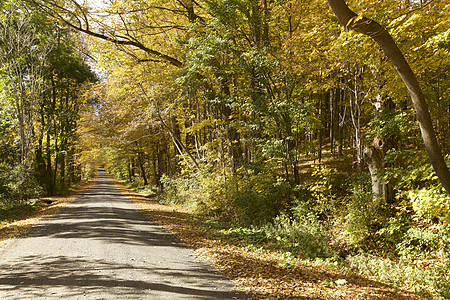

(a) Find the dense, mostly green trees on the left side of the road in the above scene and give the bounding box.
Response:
[0,1,96,203]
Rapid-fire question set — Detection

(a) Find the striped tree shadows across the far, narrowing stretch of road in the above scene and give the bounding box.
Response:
[23,173,184,247]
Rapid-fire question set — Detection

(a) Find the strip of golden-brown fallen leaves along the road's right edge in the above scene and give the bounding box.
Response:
[116,182,421,299]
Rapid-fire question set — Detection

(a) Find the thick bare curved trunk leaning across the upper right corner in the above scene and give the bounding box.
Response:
[328,0,450,194]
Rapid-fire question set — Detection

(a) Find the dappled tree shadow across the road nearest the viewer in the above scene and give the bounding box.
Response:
[0,256,244,299]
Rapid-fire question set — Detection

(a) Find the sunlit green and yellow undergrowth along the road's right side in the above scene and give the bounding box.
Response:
[129,163,450,299]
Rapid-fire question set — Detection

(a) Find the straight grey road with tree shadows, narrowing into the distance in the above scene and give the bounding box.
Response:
[0,171,247,299]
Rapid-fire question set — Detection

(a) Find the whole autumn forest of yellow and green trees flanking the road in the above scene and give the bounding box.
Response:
[0,0,450,299]
